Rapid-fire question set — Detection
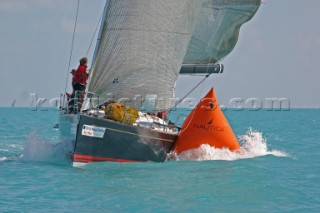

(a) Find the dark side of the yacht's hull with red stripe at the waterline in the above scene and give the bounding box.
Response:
[60,115,177,163]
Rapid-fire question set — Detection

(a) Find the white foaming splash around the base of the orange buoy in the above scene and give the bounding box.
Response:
[167,129,289,161]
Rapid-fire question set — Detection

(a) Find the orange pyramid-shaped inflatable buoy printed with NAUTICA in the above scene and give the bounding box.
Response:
[173,88,240,154]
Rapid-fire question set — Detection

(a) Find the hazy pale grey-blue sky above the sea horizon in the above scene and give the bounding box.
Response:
[0,0,320,108]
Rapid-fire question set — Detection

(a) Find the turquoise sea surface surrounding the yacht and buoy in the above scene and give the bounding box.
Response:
[0,108,320,212]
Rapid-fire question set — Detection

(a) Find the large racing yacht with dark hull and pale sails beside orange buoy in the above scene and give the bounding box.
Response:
[59,0,261,164]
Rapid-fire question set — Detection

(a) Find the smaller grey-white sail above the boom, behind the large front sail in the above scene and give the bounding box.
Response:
[183,0,261,64]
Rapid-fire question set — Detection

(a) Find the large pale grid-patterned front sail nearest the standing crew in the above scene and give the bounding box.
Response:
[88,0,201,111]
